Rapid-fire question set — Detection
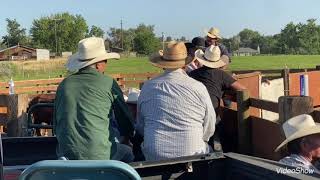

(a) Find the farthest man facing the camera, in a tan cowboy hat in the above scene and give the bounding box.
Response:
[206,27,231,63]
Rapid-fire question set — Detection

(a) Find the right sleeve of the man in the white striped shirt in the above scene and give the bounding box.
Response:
[202,88,216,142]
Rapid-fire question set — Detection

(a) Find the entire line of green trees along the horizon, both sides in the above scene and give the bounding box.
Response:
[0,13,320,55]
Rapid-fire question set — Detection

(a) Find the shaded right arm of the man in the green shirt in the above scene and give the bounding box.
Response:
[112,80,134,141]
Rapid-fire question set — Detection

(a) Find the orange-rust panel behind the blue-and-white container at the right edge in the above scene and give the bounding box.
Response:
[289,71,320,106]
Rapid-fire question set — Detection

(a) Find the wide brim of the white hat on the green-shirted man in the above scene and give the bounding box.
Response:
[66,52,120,71]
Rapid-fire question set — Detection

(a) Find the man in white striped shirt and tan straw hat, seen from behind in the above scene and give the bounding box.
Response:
[136,42,216,160]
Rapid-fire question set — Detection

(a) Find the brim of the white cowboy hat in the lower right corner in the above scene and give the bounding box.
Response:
[275,123,320,152]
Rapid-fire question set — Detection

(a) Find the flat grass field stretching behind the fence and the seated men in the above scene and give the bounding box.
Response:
[0,55,320,81]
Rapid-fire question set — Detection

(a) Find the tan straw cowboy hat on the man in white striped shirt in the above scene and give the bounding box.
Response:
[149,41,193,69]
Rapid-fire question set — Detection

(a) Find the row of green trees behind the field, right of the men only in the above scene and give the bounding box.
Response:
[223,19,320,55]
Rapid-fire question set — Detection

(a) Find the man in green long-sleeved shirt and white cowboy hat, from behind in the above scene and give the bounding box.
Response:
[54,37,134,160]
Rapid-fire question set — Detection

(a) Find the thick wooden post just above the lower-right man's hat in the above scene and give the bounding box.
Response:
[278,96,313,124]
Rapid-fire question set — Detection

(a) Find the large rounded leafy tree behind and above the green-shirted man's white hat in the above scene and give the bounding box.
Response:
[30,13,88,52]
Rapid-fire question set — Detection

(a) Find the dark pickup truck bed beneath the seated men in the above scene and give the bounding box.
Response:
[3,137,320,180]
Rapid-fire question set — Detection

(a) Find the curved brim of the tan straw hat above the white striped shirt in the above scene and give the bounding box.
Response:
[149,52,194,69]
